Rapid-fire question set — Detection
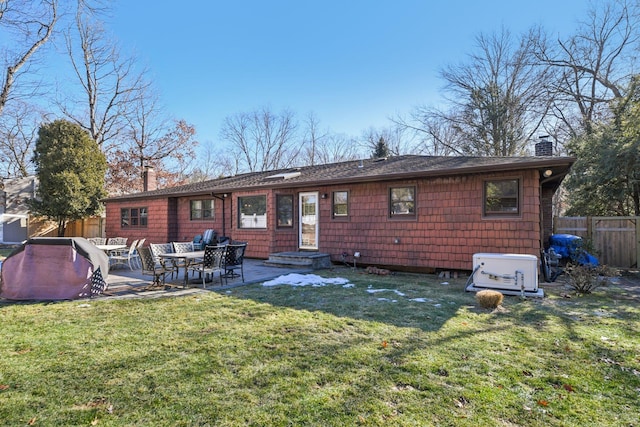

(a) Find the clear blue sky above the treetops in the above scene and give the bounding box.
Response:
[108,0,588,144]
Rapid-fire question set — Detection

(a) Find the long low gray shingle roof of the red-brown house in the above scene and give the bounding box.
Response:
[106,155,575,201]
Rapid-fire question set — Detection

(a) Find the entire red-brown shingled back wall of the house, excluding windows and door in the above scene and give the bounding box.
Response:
[106,171,541,270]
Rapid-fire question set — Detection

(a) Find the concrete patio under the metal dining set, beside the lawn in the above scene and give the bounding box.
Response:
[95,258,313,299]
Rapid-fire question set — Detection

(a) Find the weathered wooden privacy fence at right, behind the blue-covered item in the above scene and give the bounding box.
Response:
[553,216,640,268]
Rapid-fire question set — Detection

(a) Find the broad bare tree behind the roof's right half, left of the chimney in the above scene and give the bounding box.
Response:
[396,28,551,156]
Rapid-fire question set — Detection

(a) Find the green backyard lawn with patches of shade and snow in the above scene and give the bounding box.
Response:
[0,269,640,426]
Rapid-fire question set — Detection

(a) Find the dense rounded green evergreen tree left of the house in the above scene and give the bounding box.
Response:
[30,120,107,237]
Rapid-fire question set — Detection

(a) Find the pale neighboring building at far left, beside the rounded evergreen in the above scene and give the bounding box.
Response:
[0,176,38,244]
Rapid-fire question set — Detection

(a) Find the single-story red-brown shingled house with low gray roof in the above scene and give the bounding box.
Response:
[105,156,575,270]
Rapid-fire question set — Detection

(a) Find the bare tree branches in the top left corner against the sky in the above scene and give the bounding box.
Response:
[0,0,58,115]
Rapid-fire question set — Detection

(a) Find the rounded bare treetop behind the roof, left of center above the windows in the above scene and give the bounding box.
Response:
[220,107,302,173]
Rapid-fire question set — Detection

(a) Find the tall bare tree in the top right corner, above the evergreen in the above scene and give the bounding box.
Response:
[536,0,640,136]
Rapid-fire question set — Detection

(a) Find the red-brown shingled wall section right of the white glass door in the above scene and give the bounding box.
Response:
[320,170,540,270]
